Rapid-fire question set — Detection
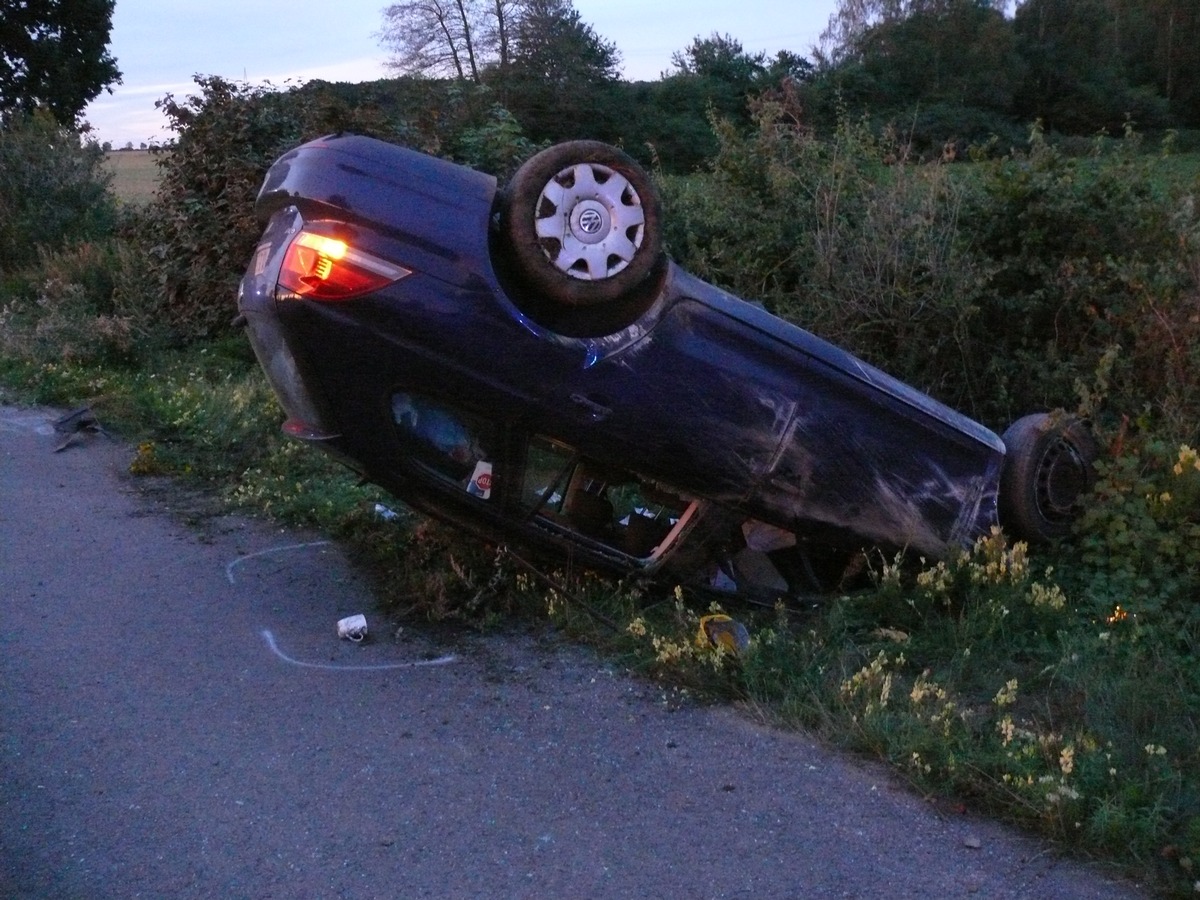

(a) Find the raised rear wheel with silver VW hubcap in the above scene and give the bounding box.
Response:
[500,140,662,308]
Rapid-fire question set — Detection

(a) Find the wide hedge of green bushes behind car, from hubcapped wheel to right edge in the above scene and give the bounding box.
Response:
[662,102,1200,439]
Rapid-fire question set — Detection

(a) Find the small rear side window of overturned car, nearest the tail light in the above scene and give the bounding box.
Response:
[391,392,498,500]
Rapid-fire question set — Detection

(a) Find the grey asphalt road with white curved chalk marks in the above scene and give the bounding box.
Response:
[0,408,1146,900]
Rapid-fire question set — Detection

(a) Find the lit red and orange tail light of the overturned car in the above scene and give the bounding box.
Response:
[280,232,413,300]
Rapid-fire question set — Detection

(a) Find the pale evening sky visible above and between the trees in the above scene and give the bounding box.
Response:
[84,0,838,146]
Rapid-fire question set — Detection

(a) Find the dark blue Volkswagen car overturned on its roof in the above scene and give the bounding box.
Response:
[239,136,1096,594]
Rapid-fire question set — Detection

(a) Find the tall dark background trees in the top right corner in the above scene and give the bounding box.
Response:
[805,0,1200,141]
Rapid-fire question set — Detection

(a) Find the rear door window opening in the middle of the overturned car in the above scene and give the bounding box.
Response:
[521,437,689,558]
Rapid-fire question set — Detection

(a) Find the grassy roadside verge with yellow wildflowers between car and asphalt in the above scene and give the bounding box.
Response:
[0,336,1200,893]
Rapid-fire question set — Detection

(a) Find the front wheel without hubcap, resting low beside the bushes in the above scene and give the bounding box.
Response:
[1000,413,1099,542]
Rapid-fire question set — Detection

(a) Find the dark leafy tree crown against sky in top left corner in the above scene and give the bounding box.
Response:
[0,0,121,126]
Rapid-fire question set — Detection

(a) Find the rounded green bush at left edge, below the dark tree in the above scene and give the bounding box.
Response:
[0,110,114,275]
